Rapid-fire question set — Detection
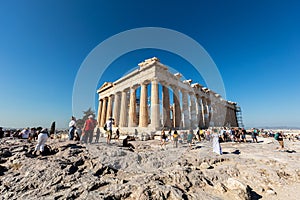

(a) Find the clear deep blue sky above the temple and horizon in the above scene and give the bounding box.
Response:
[0,0,300,128]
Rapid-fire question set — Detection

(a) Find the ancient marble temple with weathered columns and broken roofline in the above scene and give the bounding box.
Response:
[97,57,238,132]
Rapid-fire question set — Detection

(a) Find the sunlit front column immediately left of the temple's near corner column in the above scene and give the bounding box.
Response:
[139,83,148,127]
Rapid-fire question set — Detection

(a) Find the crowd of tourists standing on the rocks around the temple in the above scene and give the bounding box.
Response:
[0,119,300,155]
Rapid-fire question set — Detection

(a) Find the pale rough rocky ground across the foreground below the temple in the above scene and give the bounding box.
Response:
[0,135,300,200]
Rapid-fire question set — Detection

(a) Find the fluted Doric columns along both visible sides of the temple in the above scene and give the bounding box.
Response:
[97,79,212,128]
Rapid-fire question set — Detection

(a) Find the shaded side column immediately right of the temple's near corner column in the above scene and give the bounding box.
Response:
[162,86,172,127]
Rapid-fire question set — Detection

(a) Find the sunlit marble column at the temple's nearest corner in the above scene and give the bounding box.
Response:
[151,79,161,128]
